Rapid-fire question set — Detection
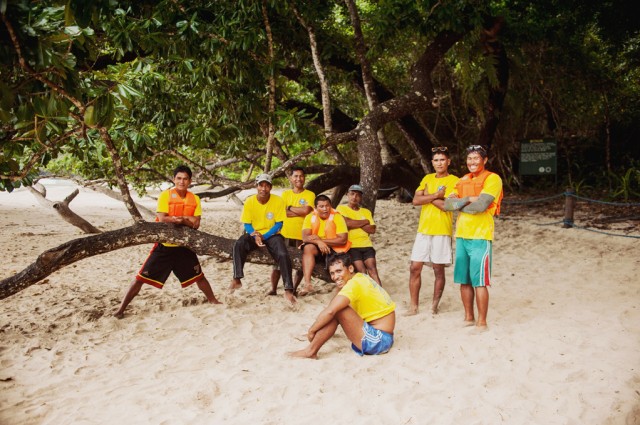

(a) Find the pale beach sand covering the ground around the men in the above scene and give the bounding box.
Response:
[0,184,640,425]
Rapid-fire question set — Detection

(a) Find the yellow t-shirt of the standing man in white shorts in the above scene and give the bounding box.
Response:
[416,173,459,236]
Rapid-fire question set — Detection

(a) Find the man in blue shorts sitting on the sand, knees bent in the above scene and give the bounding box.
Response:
[289,254,396,359]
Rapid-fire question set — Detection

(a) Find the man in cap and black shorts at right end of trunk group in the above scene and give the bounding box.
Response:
[336,184,382,286]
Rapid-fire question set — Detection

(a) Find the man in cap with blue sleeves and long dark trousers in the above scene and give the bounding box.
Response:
[229,174,296,305]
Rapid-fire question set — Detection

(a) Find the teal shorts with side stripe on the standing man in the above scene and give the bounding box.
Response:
[453,238,492,288]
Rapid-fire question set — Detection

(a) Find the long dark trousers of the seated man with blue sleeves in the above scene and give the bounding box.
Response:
[233,233,293,291]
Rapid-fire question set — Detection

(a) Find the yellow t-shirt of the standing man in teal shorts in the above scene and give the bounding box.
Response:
[454,174,502,241]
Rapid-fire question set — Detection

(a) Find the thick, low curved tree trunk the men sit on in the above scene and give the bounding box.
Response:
[0,222,331,300]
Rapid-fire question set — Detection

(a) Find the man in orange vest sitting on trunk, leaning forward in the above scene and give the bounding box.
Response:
[299,195,351,296]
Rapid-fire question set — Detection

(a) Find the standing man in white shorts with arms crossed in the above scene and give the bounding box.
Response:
[408,146,458,315]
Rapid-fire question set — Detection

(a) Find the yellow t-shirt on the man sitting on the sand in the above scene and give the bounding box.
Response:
[338,273,396,322]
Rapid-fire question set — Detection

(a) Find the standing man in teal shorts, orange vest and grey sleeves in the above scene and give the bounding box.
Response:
[444,145,502,331]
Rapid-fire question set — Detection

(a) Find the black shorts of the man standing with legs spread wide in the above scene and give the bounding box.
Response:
[136,243,204,289]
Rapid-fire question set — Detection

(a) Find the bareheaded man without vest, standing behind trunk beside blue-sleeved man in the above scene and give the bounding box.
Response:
[269,167,316,295]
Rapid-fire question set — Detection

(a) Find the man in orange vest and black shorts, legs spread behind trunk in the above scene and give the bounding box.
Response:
[114,165,221,319]
